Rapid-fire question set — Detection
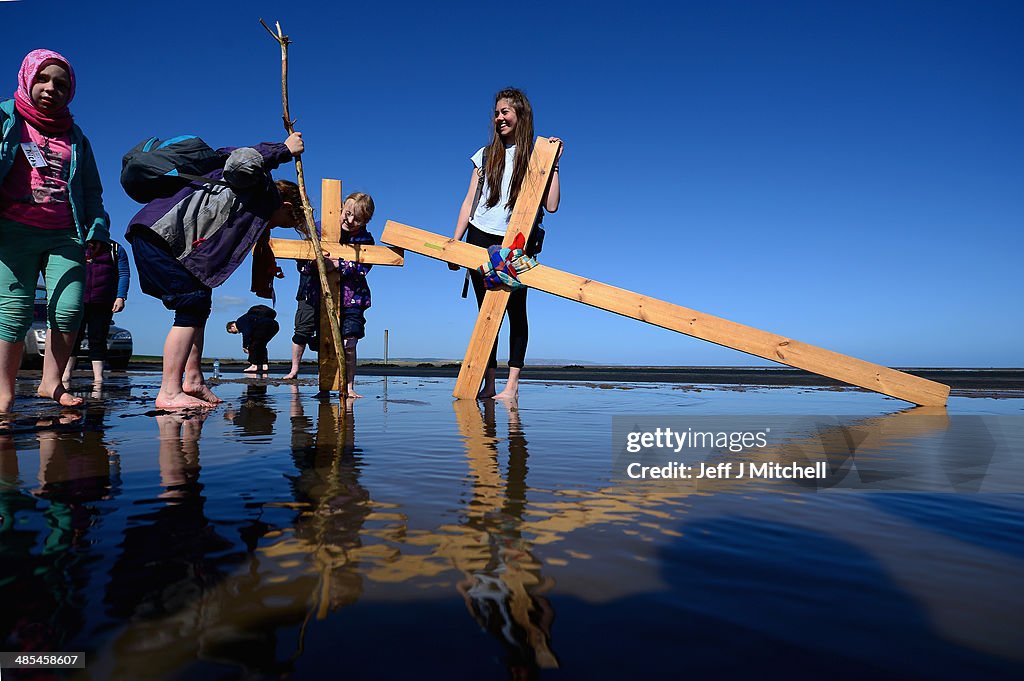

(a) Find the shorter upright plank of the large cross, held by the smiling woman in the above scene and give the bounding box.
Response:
[452,137,558,399]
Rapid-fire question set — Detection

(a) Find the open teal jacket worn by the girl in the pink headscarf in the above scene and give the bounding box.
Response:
[0,99,111,243]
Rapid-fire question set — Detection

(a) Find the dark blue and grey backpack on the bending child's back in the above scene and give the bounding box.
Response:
[121,135,227,204]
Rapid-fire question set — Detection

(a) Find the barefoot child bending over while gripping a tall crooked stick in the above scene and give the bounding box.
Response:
[127,132,305,409]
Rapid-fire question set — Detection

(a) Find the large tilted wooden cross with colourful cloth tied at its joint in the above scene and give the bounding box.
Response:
[381,137,949,407]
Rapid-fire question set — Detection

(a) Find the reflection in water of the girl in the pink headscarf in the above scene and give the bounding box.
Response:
[0,405,120,651]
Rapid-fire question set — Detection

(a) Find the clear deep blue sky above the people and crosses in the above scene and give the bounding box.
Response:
[0,0,1024,367]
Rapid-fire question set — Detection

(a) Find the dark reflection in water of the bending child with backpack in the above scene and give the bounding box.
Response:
[97,412,307,679]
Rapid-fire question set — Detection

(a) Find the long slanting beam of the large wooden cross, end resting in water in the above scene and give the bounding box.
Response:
[381,218,949,407]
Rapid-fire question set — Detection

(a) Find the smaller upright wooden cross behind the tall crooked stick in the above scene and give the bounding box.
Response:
[270,179,406,390]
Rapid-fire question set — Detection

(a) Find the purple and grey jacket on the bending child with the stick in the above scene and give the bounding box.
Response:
[126,142,292,288]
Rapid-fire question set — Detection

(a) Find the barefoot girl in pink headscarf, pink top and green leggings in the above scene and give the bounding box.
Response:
[0,49,110,414]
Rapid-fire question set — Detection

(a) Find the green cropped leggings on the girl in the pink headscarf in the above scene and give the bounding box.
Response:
[0,218,85,343]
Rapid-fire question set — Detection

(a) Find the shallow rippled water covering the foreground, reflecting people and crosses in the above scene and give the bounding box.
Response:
[0,374,1024,679]
